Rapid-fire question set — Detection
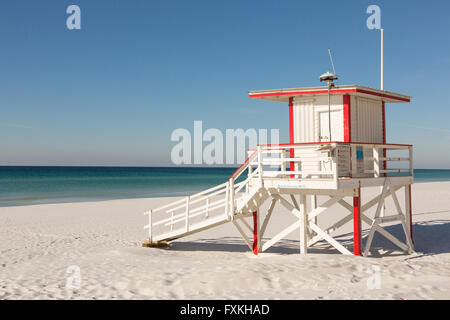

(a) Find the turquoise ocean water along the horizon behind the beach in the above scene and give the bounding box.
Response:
[0,166,450,207]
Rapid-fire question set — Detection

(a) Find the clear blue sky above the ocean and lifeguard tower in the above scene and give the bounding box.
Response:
[0,0,450,168]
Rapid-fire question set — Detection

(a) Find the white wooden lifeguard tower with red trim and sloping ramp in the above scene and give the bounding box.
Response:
[144,81,414,256]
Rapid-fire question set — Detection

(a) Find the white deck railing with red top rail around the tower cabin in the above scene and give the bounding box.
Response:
[247,142,414,181]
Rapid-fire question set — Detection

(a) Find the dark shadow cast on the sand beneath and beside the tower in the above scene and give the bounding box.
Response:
[170,220,450,258]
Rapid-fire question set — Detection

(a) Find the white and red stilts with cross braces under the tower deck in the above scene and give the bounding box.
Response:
[233,178,414,256]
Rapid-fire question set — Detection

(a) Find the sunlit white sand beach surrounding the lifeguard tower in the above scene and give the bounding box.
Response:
[0,182,450,299]
